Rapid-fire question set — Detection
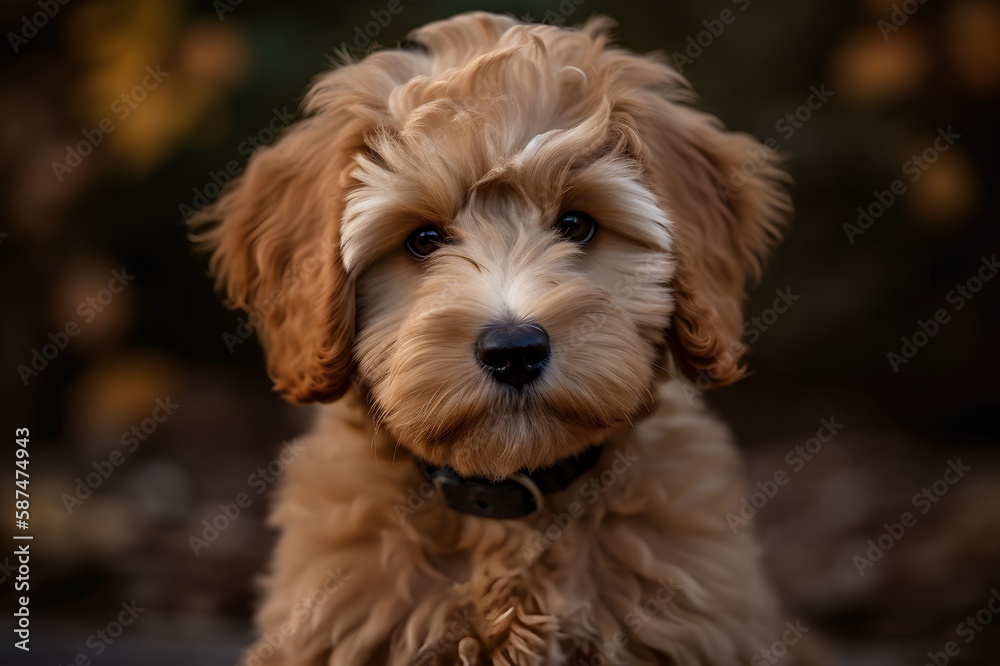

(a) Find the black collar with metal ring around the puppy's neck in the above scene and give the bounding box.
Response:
[417,446,601,518]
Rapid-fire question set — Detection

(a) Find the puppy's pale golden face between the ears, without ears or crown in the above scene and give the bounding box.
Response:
[350,123,672,476]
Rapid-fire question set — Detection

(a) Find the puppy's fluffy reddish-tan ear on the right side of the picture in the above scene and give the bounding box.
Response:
[619,58,791,387]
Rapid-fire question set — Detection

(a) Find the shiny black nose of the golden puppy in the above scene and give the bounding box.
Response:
[476,324,549,387]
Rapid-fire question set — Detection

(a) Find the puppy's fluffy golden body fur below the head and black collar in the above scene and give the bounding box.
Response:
[247,385,780,666]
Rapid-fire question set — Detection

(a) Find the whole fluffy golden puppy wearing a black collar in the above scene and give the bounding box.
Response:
[194,12,805,666]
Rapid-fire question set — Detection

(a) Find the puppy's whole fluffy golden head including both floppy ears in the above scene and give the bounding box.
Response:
[193,13,788,478]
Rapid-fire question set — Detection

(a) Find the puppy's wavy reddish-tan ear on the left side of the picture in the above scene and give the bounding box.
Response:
[192,113,364,403]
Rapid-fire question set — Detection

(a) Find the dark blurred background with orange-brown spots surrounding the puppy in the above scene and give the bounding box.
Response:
[0,0,1000,666]
